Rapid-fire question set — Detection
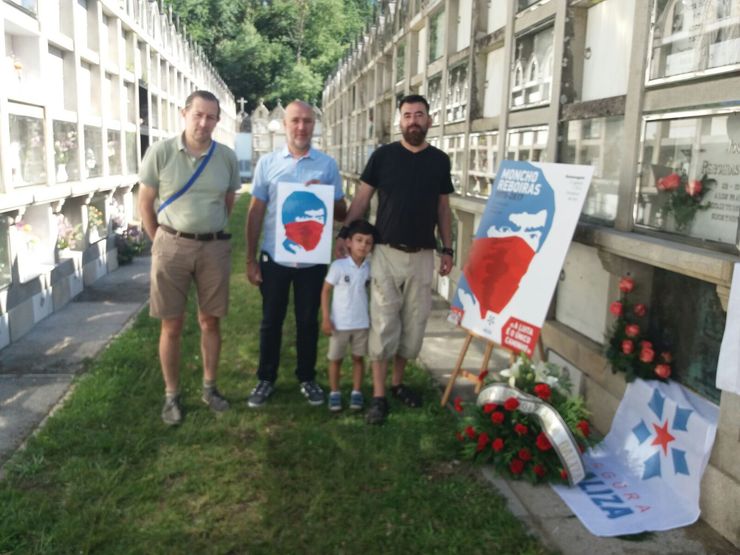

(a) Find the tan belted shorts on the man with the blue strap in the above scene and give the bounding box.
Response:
[149,229,231,319]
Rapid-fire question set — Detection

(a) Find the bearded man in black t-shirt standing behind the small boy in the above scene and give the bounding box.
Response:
[338,95,454,424]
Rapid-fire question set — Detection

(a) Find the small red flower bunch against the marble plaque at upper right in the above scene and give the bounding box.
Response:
[655,172,716,231]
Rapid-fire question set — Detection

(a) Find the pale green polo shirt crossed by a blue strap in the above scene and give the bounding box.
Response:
[139,135,241,233]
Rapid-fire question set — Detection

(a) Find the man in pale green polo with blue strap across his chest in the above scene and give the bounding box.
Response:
[139,91,241,425]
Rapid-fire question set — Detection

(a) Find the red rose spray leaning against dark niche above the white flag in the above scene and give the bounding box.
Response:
[606,277,673,382]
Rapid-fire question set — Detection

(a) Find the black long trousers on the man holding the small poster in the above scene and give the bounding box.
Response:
[257,253,327,382]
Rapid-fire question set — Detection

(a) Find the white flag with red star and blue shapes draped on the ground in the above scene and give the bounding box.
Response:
[553,380,719,536]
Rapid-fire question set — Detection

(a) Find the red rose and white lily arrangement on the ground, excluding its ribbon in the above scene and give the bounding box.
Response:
[454,355,596,483]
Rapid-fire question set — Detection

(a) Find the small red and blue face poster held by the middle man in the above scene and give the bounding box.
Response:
[275,183,334,264]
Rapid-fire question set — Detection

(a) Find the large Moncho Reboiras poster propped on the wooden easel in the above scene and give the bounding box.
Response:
[450,160,593,356]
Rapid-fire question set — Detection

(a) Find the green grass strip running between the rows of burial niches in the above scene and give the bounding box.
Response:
[0,198,549,554]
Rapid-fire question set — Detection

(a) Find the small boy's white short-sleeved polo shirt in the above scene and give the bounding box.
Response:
[325,256,370,330]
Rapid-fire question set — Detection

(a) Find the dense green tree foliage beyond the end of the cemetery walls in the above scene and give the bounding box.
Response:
[165,0,375,108]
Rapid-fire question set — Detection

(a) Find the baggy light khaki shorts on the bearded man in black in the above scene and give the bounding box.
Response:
[368,245,434,360]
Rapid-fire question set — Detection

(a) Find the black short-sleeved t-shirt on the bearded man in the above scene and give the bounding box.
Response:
[360,142,454,249]
